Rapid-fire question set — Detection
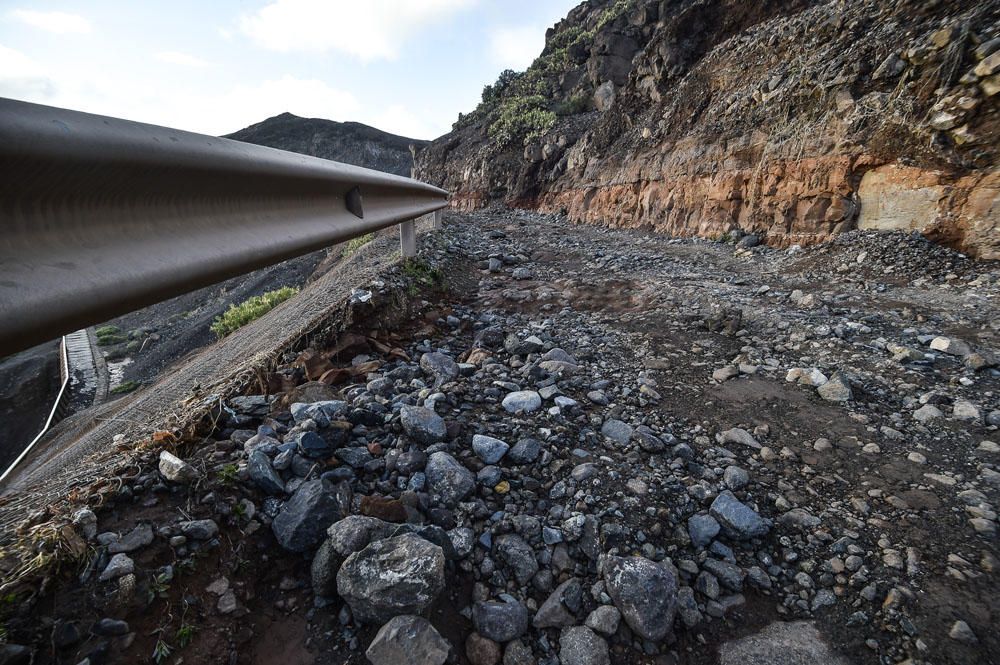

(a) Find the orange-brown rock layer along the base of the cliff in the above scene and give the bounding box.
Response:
[451,155,1000,259]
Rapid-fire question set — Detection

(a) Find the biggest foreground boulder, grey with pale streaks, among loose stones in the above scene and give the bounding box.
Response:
[337,534,444,623]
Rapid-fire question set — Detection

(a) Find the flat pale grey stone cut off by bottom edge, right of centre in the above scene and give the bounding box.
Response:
[719,621,848,665]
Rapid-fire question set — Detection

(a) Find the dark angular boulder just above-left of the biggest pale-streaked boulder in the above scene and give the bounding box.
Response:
[271,480,350,552]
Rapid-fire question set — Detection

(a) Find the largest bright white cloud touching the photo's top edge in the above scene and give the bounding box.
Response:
[239,0,477,60]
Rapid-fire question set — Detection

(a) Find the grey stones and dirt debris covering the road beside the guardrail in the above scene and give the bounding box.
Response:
[0,213,1000,665]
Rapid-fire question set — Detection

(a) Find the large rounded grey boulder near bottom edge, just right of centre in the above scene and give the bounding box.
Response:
[603,556,677,642]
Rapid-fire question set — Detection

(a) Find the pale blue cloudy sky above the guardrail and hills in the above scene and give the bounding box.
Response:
[0,0,580,139]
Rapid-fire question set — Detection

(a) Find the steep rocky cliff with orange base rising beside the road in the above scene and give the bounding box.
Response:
[417,0,1000,258]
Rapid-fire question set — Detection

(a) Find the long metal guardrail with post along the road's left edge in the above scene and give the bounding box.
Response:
[0,99,448,357]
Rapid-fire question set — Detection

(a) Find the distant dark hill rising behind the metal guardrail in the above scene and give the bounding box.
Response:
[225,113,427,177]
